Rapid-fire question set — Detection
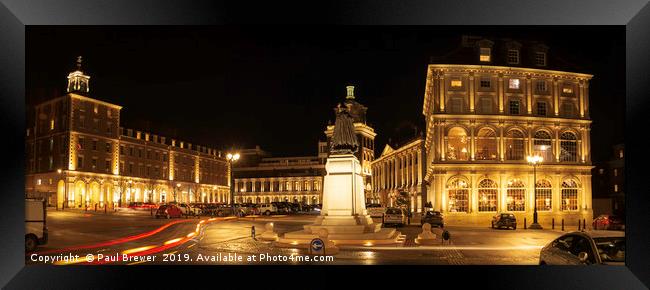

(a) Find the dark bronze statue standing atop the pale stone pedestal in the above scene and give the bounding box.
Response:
[330,104,359,154]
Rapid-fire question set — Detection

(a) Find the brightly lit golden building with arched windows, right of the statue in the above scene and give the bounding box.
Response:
[422,37,593,227]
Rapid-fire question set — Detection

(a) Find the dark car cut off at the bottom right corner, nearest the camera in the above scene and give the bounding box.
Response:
[539,231,625,265]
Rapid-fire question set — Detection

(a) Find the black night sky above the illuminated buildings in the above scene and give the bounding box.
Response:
[26,26,625,162]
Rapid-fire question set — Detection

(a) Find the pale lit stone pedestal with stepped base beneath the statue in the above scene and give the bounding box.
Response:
[277,154,403,247]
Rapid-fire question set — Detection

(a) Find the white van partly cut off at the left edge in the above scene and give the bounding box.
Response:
[25,198,47,252]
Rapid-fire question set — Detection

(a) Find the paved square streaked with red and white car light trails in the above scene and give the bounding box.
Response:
[26,210,563,265]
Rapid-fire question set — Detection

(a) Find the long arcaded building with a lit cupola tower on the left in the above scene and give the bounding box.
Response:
[25,58,229,208]
